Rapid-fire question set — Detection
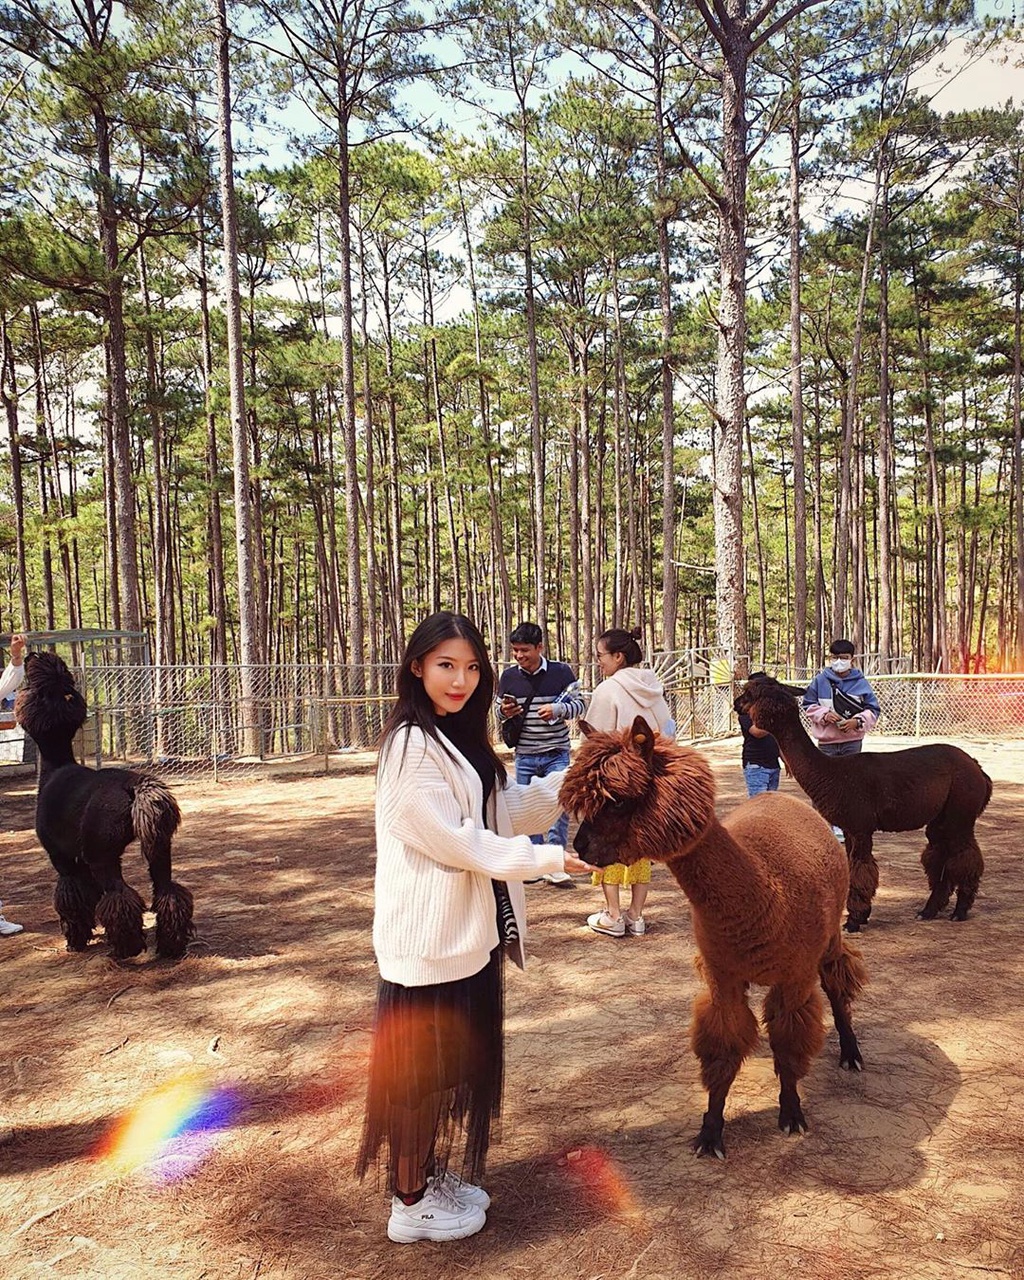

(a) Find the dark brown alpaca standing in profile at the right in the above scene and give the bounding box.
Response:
[736,676,992,933]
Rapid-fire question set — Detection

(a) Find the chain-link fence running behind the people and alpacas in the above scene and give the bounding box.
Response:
[0,650,1024,781]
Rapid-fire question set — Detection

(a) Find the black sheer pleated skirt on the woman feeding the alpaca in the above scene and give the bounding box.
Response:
[356,947,504,1190]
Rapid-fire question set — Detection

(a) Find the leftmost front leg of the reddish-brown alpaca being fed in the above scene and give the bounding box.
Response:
[690,983,758,1160]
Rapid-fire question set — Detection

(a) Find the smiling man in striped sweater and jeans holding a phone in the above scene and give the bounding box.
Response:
[495,622,585,888]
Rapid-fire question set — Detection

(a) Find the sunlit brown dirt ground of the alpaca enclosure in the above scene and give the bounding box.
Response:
[0,740,1024,1280]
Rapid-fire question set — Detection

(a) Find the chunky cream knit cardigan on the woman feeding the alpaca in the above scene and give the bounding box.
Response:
[374,726,564,987]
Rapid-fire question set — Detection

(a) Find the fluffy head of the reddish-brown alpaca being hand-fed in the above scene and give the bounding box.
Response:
[559,716,714,867]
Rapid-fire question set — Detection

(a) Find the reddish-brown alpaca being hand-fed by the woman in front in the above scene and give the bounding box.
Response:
[561,717,865,1157]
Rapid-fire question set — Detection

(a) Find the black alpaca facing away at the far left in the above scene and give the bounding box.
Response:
[14,653,195,960]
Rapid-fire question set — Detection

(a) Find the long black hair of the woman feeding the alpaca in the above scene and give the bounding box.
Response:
[380,609,507,786]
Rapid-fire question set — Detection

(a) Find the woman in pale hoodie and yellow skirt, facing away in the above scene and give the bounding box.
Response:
[586,627,671,938]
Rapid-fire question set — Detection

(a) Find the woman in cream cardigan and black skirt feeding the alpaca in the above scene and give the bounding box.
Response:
[356,613,593,1243]
